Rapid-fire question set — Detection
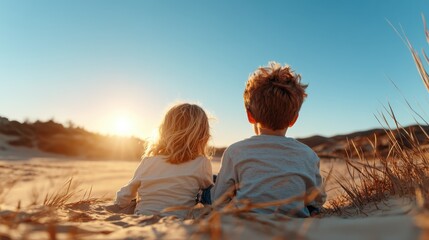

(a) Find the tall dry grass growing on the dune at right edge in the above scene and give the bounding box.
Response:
[328,16,429,215]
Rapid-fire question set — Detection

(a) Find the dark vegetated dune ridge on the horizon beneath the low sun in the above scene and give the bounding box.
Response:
[0,118,145,160]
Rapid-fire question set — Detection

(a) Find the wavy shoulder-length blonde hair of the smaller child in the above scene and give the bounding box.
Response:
[146,103,210,164]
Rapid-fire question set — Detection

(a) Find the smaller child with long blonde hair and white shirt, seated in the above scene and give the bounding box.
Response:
[115,103,213,218]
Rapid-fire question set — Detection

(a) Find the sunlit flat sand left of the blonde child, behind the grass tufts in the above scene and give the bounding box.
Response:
[0,158,220,206]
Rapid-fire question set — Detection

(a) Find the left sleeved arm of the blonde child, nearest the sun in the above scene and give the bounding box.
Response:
[115,160,144,208]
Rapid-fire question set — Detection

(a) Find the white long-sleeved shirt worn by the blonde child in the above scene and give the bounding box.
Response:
[115,156,213,218]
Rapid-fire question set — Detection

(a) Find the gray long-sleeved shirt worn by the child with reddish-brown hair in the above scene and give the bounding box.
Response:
[211,135,326,217]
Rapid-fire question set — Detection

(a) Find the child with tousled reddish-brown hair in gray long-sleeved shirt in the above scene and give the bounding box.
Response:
[211,62,325,217]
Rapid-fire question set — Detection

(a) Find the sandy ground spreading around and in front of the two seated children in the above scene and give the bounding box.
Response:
[0,141,429,240]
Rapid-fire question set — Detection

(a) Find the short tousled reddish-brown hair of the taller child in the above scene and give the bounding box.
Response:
[244,62,307,130]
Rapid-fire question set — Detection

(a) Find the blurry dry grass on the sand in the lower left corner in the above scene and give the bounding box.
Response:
[0,178,100,239]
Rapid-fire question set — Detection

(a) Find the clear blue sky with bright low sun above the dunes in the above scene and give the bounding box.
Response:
[0,0,429,146]
